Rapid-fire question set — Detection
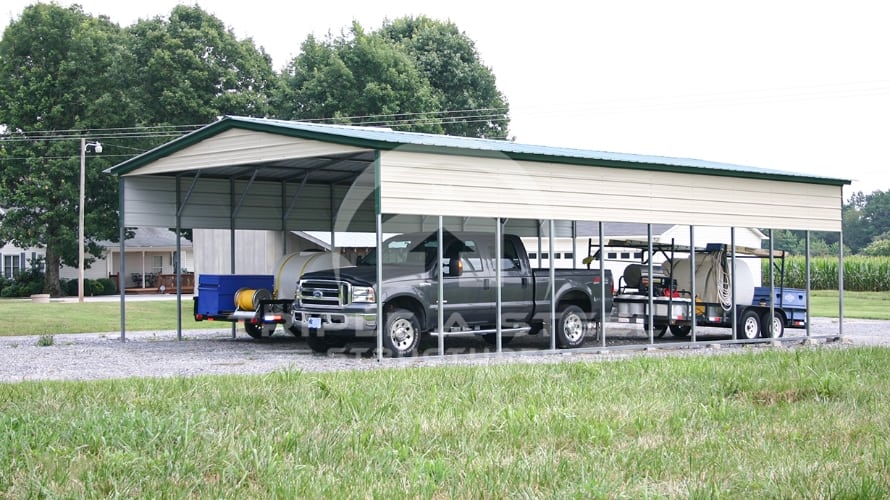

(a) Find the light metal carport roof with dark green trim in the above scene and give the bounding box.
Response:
[106,116,851,186]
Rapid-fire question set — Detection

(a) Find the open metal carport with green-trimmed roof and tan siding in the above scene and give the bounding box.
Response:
[107,117,850,358]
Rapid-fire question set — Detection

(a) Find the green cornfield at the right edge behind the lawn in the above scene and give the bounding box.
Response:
[763,255,890,292]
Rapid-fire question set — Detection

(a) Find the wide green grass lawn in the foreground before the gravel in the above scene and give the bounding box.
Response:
[0,347,890,498]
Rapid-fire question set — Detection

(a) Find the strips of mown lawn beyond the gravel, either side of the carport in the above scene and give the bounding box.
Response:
[0,291,890,335]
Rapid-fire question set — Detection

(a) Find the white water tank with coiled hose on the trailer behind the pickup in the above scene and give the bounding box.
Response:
[665,254,759,305]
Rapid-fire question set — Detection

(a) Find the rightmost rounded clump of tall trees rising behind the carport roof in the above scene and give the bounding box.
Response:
[275,18,507,137]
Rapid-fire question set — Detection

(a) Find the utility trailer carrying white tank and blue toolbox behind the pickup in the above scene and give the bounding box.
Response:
[584,240,807,340]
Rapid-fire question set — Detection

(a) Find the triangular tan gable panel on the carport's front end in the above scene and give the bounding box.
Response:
[119,129,365,176]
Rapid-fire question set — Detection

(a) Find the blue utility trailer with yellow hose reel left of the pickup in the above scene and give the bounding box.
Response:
[193,274,293,339]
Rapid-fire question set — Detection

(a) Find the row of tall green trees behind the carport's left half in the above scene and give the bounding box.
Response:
[0,3,509,295]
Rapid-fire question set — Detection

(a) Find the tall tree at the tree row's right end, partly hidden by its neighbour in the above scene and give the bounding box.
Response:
[378,16,509,139]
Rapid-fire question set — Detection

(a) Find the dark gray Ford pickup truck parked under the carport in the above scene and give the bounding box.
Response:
[292,231,613,357]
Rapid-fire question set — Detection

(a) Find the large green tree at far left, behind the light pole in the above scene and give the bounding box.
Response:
[0,4,127,295]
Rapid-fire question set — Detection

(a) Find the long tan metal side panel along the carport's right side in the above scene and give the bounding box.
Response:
[380,151,843,231]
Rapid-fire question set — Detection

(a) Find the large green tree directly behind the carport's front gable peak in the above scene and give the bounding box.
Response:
[128,5,276,125]
